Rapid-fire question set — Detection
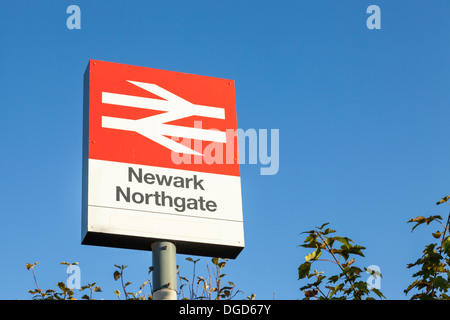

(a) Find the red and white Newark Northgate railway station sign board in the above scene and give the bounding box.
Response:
[82,60,244,258]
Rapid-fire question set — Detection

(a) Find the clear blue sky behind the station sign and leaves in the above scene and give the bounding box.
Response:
[0,0,450,299]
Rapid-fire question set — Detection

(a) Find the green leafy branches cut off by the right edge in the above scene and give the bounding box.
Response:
[404,196,450,300]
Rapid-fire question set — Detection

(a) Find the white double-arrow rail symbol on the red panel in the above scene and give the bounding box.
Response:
[102,80,226,156]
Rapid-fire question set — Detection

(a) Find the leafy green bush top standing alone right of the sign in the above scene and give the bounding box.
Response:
[298,223,384,300]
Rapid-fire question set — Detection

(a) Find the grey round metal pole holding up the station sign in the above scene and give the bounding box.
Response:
[152,241,177,300]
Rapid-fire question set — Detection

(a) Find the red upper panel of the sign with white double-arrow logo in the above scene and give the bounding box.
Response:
[85,60,239,176]
